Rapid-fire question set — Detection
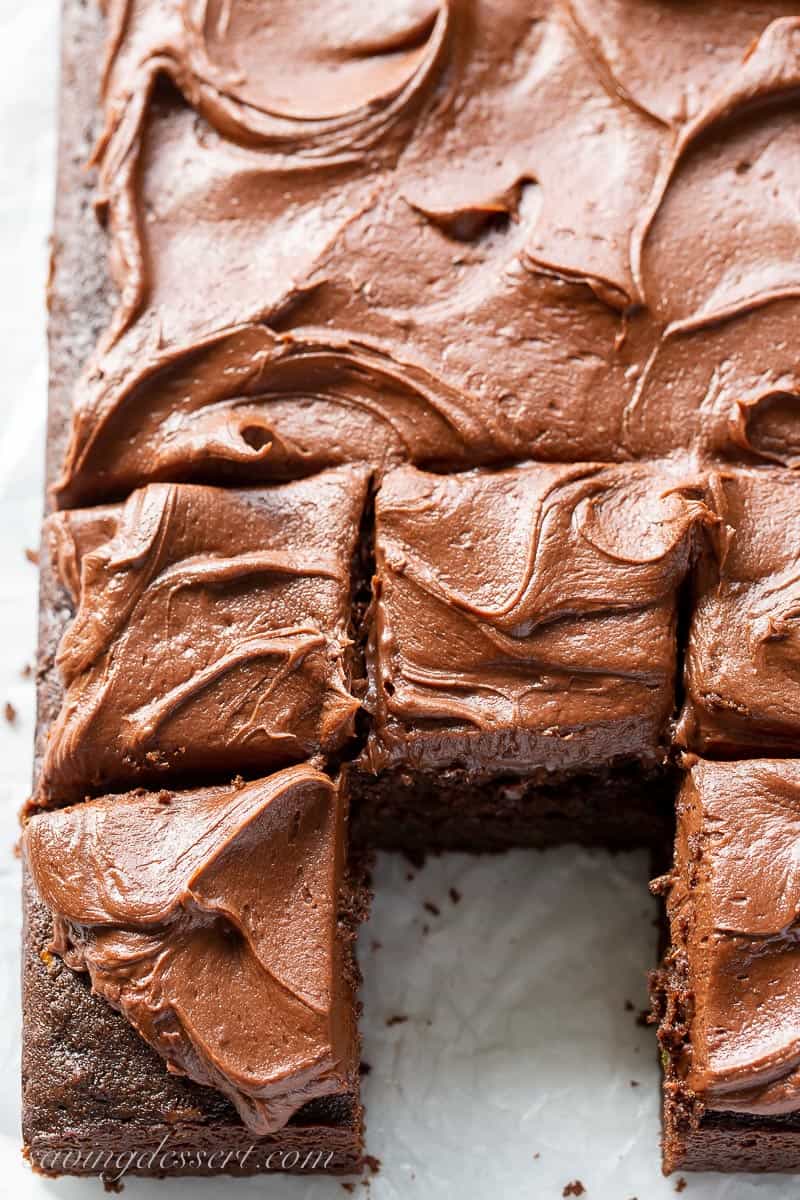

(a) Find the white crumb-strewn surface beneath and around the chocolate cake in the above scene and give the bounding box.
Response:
[0,0,800,1200]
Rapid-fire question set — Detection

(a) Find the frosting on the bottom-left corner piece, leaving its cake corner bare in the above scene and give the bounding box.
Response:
[24,766,357,1135]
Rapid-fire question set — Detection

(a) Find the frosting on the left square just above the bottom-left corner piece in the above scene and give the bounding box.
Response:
[35,468,367,804]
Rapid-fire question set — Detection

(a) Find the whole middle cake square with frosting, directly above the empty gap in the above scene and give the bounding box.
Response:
[354,453,711,850]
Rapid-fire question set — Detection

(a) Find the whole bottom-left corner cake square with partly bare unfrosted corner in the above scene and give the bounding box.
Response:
[23,764,367,1178]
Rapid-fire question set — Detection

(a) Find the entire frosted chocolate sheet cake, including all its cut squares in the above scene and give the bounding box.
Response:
[23,0,800,1175]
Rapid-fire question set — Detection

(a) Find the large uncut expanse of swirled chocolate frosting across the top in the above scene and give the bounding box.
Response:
[56,0,800,503]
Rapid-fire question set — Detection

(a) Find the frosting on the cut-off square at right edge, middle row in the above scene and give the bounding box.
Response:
[678,469,800,756]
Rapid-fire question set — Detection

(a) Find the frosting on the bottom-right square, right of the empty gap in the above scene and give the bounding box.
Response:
[668,760,800,1116]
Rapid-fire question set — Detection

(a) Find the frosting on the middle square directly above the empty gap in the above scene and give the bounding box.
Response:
[365,464,711,775]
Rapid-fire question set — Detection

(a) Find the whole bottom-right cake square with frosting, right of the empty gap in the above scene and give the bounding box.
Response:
[652,760,800,1171]
